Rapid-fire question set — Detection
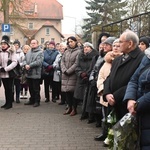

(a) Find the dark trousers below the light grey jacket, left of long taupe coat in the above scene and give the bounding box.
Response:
[53,81,61,98]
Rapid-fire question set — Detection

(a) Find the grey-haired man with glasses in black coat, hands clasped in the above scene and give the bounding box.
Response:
[103,30,144,120]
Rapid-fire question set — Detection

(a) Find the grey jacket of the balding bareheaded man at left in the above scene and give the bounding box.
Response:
[23,47,44,79]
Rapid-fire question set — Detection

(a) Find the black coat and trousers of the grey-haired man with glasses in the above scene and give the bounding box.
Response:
[103,47,144,119]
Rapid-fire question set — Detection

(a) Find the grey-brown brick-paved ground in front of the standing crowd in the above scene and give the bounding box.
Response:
[0,84,106,150]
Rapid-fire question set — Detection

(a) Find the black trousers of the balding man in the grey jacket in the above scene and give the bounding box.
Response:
[28,78,41,103]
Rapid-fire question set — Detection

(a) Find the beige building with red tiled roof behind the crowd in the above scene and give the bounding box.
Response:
[0,0,64,45]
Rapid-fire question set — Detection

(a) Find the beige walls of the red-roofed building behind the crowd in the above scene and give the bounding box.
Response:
[6,19,62,45]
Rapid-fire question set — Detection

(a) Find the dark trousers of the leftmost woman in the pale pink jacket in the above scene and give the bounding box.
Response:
[2,78,14,107]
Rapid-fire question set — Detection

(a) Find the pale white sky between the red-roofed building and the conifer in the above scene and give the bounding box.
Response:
[57,0,87,34]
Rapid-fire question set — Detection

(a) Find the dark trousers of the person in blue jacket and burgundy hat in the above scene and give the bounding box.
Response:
[44,76,55,100]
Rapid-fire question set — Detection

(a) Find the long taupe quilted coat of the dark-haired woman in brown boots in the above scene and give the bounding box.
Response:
[61,47,81,92]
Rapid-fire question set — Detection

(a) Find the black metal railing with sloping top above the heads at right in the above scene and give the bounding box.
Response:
[102,12,150,37]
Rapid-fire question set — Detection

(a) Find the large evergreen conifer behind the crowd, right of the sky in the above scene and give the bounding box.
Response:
[82,0,127,40]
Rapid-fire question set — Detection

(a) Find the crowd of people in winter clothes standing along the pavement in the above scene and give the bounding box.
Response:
[0,30,150,150]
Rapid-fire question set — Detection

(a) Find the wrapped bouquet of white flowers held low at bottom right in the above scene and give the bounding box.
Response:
[108,113,138,150]
